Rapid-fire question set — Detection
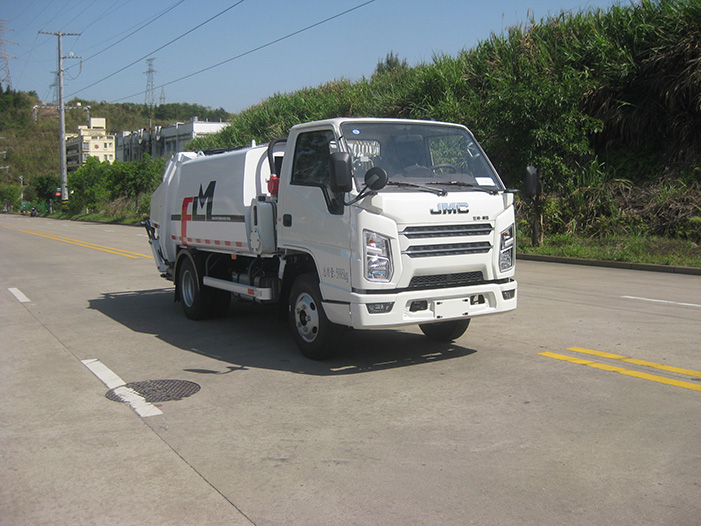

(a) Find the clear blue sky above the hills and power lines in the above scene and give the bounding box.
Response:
[0,0,616,112]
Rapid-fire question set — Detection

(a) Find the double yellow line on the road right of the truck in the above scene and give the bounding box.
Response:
[538,347,701,391]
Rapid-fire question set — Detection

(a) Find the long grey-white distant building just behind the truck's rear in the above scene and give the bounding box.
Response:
[115,117,229,161]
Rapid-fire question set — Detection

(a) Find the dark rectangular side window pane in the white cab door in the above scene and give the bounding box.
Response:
[291,130,334,186]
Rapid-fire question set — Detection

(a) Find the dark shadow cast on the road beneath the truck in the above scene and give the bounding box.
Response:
[90,288,477,376]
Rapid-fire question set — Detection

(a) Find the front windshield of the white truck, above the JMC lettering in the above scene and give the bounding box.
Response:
[341,122,504,191]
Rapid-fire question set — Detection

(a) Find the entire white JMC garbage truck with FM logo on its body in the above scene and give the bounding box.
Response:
[144,118,534,359]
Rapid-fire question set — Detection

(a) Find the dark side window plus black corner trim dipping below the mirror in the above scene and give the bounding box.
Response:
[290,130,343,215]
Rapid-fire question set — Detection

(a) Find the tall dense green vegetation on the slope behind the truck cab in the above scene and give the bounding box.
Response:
[191,0,701,248]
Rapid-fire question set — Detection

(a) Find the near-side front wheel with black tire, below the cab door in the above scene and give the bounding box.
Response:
[288,274,339,360]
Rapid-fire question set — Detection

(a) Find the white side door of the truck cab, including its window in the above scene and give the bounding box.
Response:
[278,127,351,300]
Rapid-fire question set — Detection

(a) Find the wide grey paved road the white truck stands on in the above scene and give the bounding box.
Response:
[0,215,701,526]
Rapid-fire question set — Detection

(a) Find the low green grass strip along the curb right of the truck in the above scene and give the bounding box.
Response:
[518,235,701,267]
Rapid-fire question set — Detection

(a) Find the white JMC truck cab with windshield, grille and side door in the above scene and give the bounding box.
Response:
[277,119,517,358]
